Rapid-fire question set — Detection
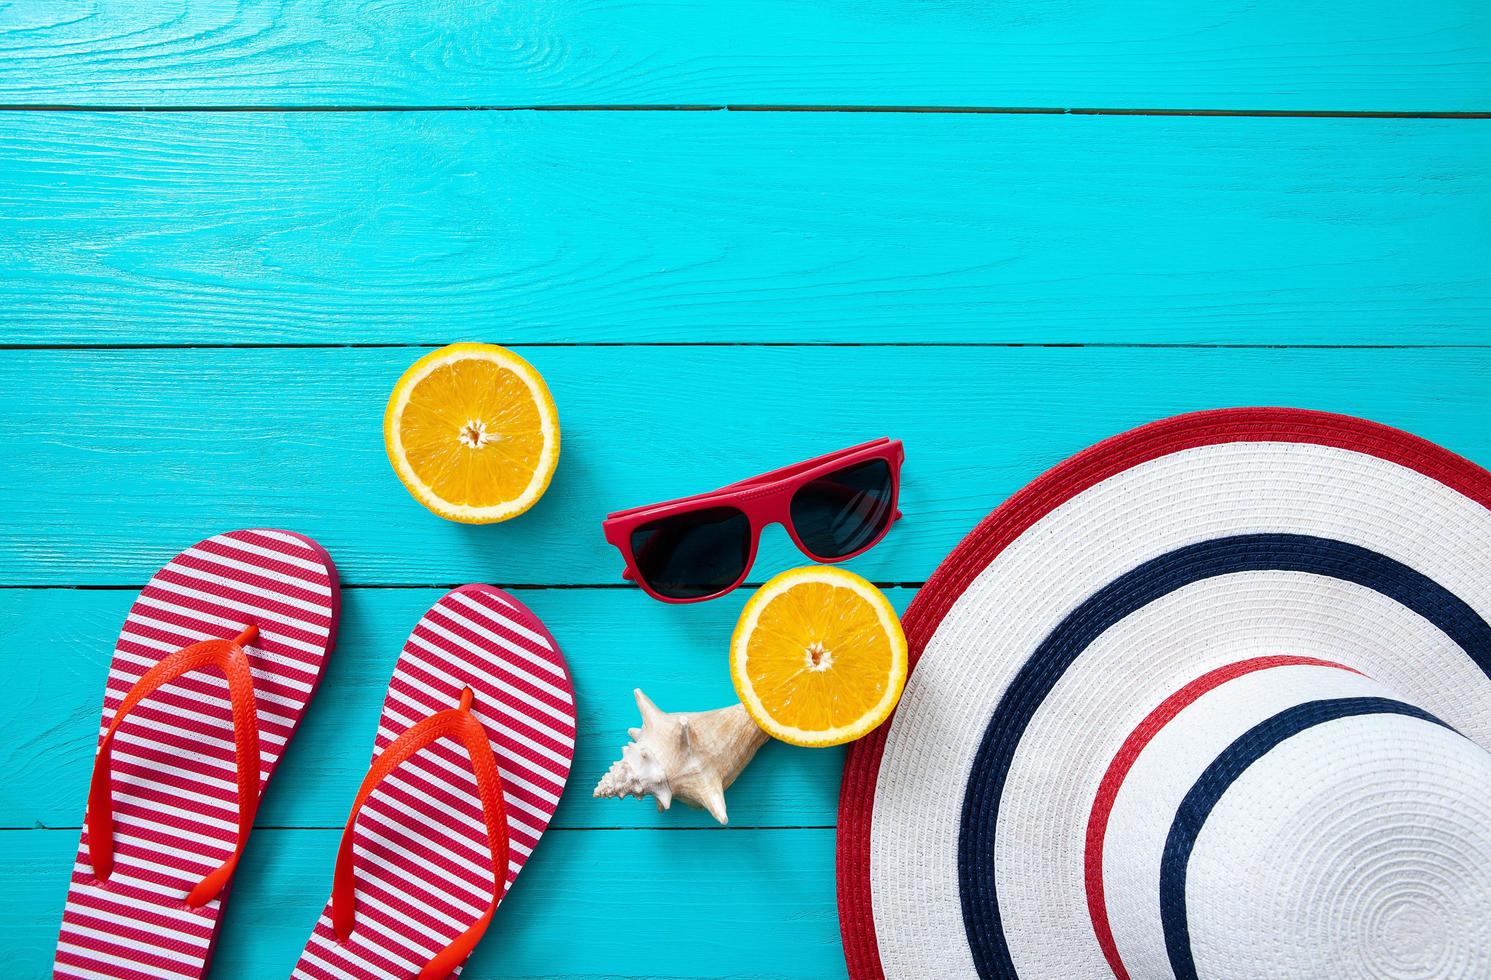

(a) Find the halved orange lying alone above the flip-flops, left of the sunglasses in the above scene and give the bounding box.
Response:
[383,343,559,524]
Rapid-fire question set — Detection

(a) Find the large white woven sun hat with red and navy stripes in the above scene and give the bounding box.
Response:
[838,409,1491,980]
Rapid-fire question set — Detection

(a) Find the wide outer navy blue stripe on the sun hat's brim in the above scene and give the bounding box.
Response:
[957,534,1491,980]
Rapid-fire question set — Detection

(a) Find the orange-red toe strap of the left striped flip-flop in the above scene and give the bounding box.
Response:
[86,625,259,908]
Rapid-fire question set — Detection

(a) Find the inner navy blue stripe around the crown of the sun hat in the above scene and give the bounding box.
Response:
[1160,698,1454,980]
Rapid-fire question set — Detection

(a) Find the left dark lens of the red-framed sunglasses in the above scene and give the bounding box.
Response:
[632,507,750,598]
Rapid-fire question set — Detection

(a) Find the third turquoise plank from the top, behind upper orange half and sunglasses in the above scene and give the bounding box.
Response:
[0,346,1491,584]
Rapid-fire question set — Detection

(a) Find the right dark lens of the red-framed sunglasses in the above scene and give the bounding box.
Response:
[792,459,893,558]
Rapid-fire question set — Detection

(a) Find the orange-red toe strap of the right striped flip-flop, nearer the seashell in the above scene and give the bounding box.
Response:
[331,688,507,980]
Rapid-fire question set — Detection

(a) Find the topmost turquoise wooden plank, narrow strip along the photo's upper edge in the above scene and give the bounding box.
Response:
[0,0,1491,110]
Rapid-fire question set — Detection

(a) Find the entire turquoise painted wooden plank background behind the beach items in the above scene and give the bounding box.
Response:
[0,0,1491,980]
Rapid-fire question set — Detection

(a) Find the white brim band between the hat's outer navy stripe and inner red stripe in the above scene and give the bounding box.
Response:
[996,571,1491,976]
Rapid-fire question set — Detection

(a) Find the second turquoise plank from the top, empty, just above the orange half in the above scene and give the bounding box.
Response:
[0,111,1491,345]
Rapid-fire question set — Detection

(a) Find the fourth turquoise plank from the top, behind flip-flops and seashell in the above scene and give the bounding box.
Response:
[0,589,894,828]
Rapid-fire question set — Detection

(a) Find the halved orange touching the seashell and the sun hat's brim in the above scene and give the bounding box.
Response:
[731,565,907,746]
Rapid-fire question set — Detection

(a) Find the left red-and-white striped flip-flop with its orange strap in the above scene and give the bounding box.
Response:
[52,530,340,980]
